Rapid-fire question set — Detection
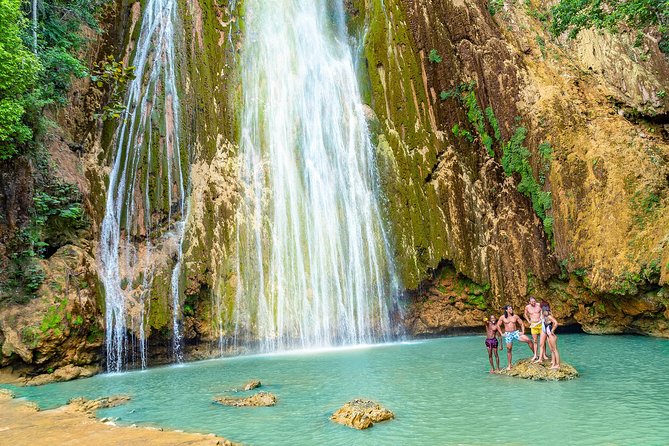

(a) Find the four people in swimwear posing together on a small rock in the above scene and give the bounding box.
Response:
[484,297,560,373]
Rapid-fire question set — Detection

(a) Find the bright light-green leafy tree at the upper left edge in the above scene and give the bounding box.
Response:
[0,0,40,160]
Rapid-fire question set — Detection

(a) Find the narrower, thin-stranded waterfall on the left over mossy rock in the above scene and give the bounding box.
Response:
[100,0,188,371]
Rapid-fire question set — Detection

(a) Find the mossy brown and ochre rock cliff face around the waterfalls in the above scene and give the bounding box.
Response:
[0,0,669,373]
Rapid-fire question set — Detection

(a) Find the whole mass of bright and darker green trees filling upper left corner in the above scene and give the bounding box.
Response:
[0,0,109,160]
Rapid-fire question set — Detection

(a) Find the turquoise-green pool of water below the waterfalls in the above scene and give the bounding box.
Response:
[5,335,669,446]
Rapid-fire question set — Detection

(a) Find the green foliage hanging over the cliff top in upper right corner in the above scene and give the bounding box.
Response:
[550,0,669,54]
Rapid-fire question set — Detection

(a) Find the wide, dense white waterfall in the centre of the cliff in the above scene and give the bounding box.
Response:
[235,0,398,350]
